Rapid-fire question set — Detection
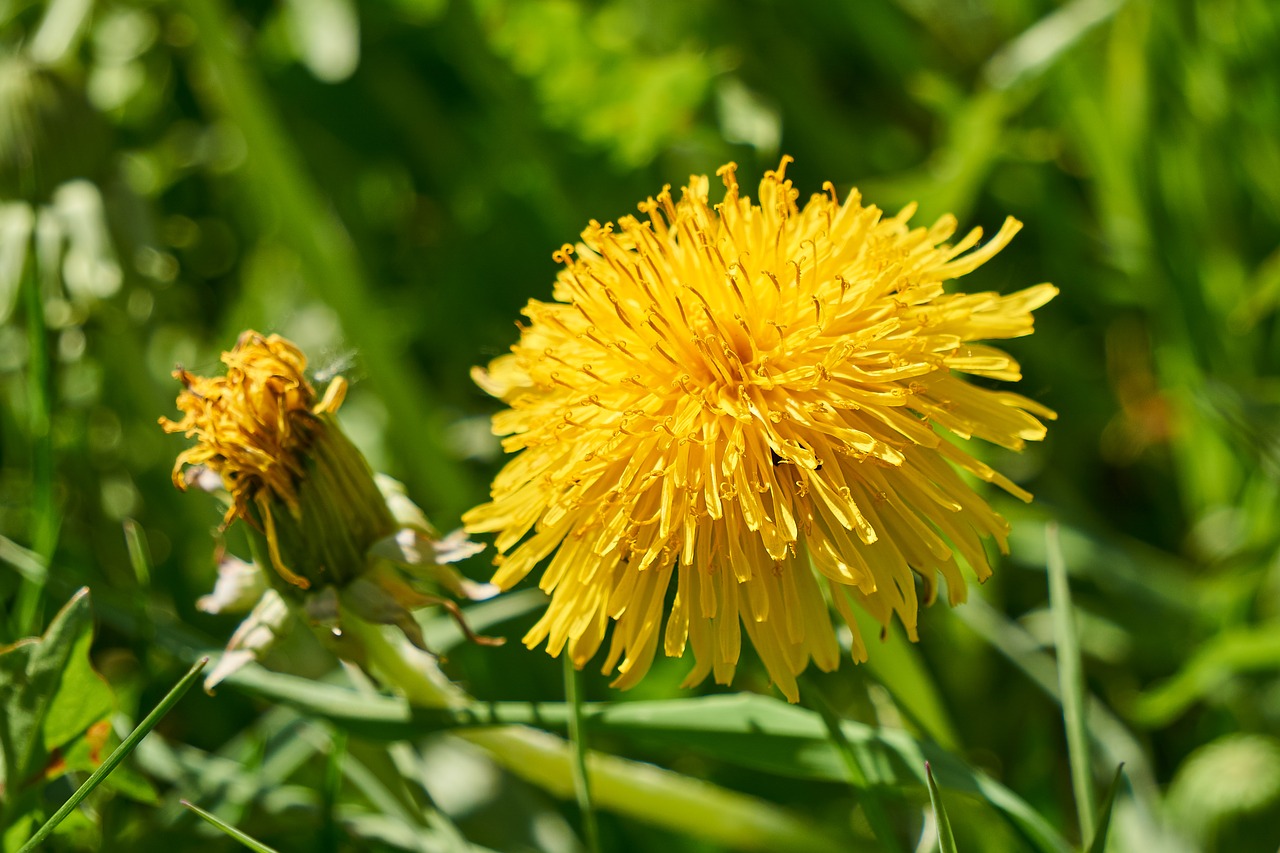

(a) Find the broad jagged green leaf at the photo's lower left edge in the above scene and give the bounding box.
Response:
[0,589,115,794]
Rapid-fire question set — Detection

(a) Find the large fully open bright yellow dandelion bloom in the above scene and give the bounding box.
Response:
[465,158,1057,701]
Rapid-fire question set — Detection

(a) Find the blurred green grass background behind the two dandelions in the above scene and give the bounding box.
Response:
[0,0,1280,853]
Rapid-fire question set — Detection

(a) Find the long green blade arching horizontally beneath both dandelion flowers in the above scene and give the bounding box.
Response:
[228,666,1070,853]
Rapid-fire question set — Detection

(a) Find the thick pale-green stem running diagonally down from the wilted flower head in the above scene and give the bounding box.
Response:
[342,611,845,853]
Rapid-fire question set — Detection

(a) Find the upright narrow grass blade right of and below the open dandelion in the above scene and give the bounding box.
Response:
[1044,524,1094,839]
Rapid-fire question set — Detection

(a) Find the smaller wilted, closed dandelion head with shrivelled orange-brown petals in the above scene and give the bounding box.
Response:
[160,332,495,686]
